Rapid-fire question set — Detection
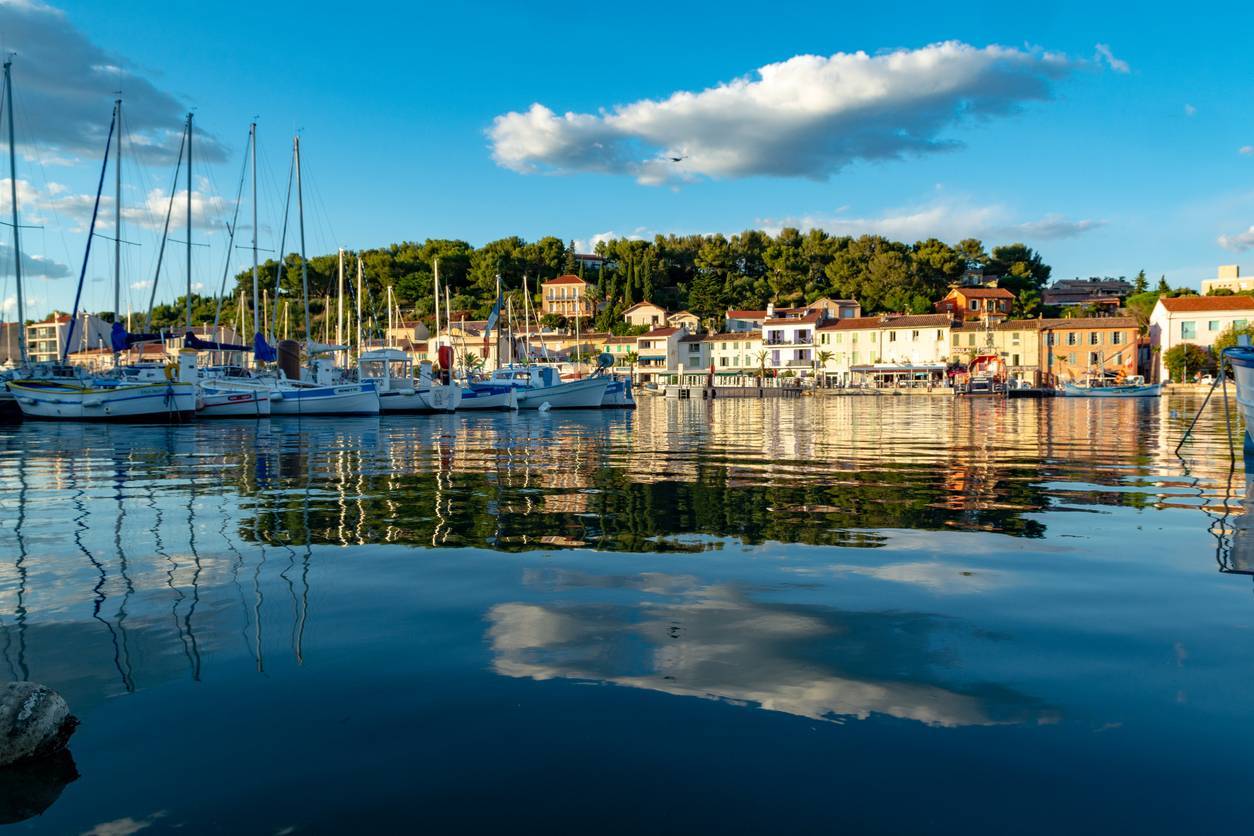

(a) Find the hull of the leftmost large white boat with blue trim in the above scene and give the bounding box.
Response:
[9,380,196,422]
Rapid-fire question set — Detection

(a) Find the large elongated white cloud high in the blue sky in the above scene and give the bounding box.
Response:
[488,41,1081,183]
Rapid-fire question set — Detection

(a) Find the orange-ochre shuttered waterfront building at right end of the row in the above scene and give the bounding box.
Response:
[1036,318,1143,385]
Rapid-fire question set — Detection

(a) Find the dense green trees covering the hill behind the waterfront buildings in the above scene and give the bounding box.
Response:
[129,228,1051,333]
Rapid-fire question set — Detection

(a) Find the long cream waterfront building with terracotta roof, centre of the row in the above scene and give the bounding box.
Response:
[816,313,953,386]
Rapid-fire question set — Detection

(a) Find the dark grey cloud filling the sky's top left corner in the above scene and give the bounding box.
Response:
[0,0,226,162]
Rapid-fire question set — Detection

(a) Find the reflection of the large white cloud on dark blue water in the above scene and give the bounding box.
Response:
[488,572,1057,727]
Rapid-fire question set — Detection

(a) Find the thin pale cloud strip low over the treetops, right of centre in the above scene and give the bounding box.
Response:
[761,198,1105,241]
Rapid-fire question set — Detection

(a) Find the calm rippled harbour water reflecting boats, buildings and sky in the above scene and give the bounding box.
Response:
[0,396,1254,835]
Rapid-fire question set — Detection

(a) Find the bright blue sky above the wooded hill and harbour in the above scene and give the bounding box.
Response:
[0,0,1254,313]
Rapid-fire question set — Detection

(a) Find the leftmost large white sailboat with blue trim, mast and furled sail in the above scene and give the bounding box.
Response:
[9,97,196,421]
